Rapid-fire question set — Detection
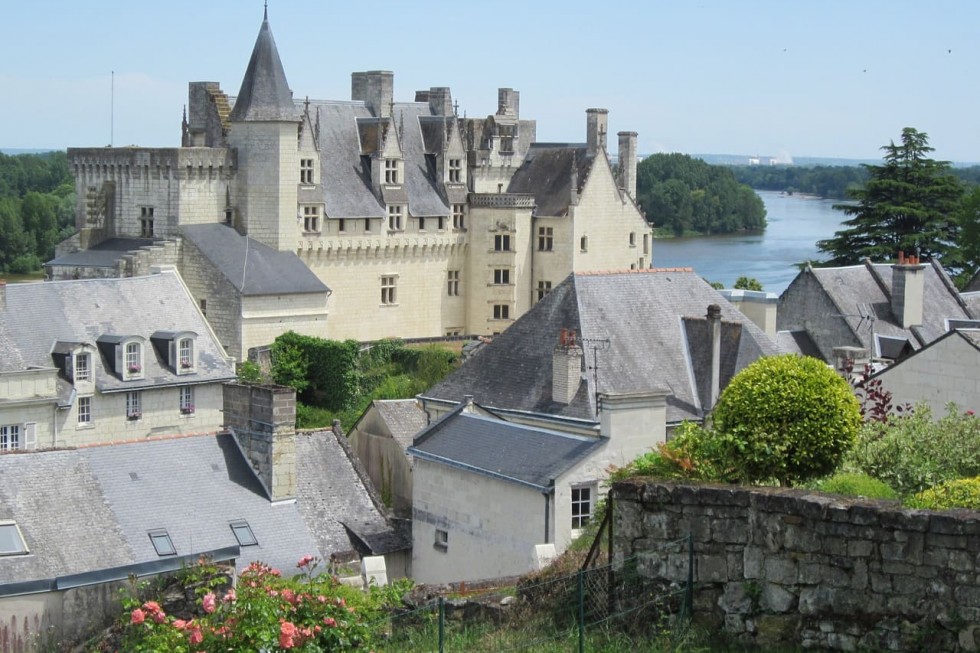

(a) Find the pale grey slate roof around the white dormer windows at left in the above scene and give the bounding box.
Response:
[0,272,235,392]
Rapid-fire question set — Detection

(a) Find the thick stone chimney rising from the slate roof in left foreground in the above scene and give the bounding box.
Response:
[223,383,296,503]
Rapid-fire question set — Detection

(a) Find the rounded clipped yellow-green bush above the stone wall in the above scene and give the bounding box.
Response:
[710,354,861,485]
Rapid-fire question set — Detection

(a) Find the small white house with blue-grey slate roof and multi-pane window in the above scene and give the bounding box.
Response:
[408,391,666,583]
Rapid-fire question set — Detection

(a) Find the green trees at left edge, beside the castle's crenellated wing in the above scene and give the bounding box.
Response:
[0,152,75,274]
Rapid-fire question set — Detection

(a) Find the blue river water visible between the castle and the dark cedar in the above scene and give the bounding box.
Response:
[653,190,846,294]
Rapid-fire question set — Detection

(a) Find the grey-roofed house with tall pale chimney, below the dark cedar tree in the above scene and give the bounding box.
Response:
[776,256,980,364]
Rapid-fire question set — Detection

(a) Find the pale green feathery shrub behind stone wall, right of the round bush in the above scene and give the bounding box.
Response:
[845,405,980,496]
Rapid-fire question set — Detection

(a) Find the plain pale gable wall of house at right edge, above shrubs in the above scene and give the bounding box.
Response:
[872,329,980,417]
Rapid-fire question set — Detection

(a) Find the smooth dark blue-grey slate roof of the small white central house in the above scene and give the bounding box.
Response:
[408,410,608,491]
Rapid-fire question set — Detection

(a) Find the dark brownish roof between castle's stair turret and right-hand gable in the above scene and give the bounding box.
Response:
[507,143,596,216]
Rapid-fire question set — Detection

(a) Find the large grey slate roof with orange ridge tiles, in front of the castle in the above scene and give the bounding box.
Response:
[424,268,780,422]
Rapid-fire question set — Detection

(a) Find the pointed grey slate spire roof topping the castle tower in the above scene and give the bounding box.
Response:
[230,10,299,121]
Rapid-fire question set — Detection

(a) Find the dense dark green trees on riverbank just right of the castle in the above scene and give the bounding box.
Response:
[636,154,766,235]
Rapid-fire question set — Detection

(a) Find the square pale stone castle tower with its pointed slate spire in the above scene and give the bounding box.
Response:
[228,10,300,251]
